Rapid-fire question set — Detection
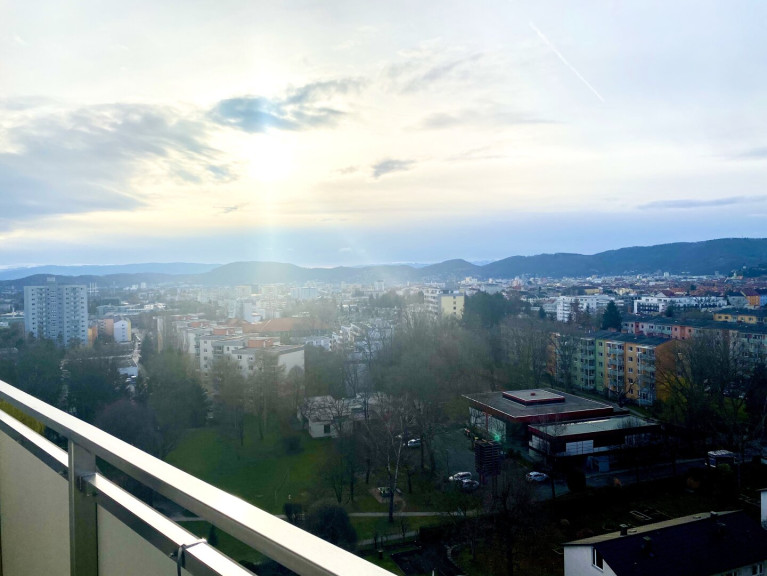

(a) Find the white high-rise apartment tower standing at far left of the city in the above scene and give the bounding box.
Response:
[24,282,88,346]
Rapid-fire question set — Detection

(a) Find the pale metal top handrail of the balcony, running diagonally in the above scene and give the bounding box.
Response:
[0,380,390,576]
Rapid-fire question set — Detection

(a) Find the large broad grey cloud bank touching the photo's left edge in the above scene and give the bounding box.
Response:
[0,101,218,222]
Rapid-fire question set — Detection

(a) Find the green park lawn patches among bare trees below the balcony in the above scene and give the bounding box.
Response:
[167,419,452,573]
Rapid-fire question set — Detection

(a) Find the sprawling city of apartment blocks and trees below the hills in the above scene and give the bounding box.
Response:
[0,240,767,575]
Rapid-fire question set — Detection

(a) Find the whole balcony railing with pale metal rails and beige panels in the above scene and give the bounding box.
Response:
[0,381,390,576]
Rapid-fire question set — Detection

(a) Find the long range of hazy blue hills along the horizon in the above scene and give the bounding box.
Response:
[0,238,767,287]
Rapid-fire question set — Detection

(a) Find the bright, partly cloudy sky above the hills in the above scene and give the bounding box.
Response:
[0,0,767,268]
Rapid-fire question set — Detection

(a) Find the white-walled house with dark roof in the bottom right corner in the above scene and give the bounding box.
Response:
[564,491,767,576]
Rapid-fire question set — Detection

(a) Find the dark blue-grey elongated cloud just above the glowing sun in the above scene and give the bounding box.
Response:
[209,78,364,133]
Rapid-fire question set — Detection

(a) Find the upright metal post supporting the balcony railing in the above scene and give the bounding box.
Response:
[69,440,99,576]
